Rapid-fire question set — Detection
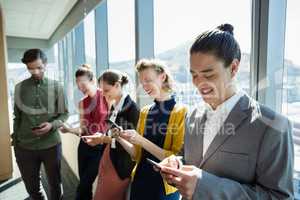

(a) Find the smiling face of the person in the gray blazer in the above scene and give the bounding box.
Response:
[190,52,239,108]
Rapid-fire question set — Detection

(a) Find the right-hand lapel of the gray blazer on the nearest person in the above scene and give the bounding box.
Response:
[199,95,250,168]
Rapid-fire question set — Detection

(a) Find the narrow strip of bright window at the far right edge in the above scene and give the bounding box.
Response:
[282,0,300,188]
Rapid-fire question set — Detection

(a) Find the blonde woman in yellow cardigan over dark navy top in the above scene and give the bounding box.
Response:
[117,59,186,200]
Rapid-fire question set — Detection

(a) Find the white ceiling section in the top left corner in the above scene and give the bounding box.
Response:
[0,0,77,39]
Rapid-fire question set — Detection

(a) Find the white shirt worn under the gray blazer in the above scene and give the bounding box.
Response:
[202,91,245,157]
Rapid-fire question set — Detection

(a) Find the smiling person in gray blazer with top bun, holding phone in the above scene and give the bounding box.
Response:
[160,24,294,200]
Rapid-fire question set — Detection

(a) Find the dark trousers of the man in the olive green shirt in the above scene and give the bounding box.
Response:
[14,144,63,200]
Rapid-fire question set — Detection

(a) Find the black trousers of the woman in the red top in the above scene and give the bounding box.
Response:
[76,140,104,200]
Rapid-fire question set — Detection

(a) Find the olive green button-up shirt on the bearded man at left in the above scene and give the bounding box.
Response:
[12,77,68,150]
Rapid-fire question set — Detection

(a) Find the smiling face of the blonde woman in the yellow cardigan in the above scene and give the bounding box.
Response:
[139,68,166,99]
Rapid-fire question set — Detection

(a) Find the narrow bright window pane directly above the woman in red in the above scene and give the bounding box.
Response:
[84,11,96,74]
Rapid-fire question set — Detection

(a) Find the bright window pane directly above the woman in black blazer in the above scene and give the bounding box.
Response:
[107,0,135,96]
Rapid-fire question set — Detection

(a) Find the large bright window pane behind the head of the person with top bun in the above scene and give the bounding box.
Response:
[154,0,252,109]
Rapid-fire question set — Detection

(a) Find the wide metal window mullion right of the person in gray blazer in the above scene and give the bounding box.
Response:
[251,0,286,112]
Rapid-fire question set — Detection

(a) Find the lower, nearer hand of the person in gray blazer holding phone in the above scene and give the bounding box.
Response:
[161,165,202,200]
